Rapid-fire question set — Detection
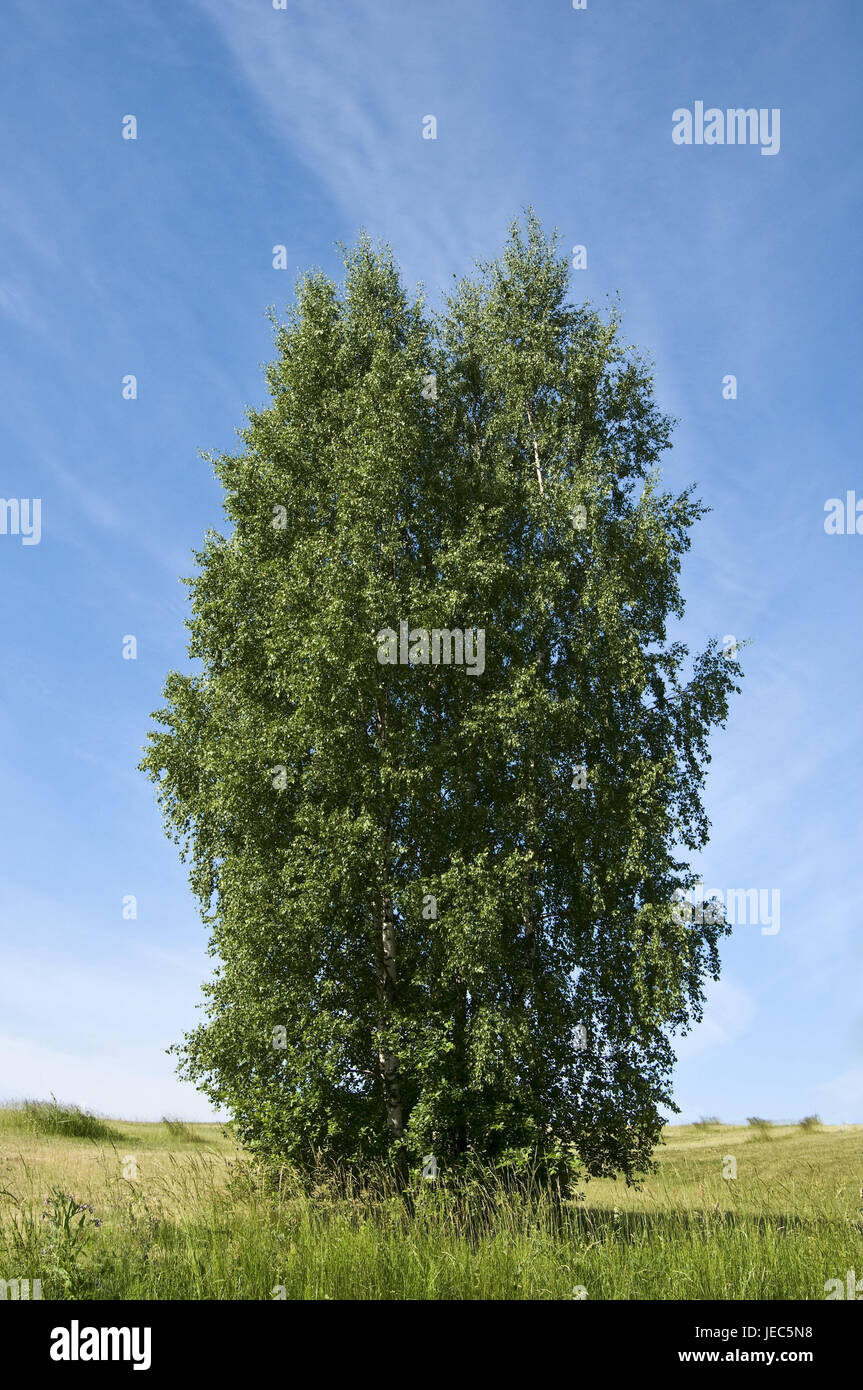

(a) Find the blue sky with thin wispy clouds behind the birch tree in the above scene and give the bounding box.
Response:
[0,0,863,1123]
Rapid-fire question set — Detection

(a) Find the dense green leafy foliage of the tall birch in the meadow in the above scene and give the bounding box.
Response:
[143,215,739,1182]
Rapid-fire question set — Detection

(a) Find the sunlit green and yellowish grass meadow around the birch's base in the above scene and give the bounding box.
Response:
[0,1106,863,1300]
